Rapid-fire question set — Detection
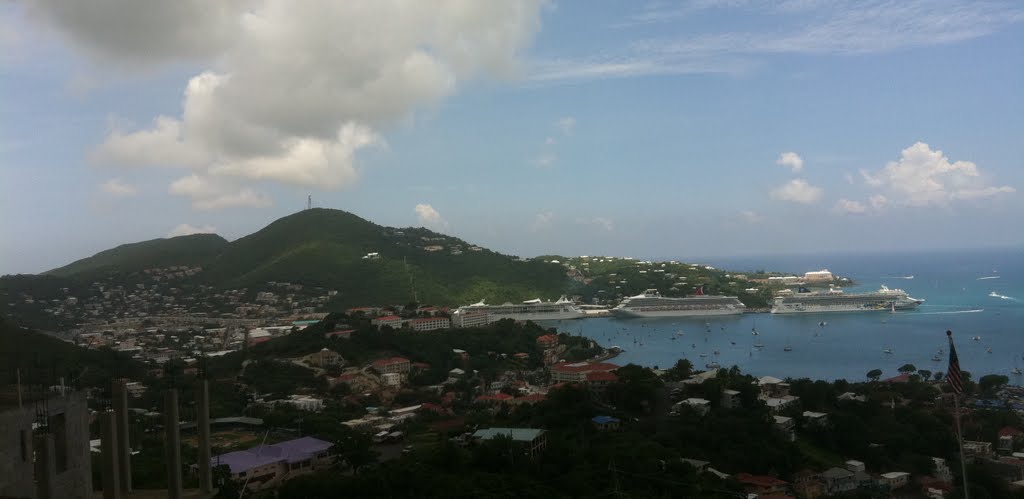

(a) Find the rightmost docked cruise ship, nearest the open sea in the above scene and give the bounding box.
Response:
[771,286,925,314]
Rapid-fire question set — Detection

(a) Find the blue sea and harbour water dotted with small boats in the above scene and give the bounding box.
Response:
[552,249,1024,384]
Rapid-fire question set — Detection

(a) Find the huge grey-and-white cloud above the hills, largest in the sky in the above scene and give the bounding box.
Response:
[47,0,543,206]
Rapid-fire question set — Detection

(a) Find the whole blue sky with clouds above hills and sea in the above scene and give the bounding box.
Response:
[0,0,1024,274]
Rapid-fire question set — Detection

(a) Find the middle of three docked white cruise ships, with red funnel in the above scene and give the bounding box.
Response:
[611,289,746,318]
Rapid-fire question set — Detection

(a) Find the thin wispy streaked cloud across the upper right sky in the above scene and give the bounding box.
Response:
[532,0,1024,83]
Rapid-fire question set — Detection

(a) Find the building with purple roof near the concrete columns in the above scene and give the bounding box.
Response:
[210,436,334,491]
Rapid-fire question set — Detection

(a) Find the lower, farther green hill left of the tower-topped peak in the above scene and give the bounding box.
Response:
[43,234,227,279]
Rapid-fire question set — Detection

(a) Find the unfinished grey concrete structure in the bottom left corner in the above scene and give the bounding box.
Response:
[0,390,92,499]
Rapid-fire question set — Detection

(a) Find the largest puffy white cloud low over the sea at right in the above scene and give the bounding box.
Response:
[860,142,1016,206]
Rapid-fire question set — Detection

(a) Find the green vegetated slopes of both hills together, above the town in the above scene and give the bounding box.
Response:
[18,209,568,309]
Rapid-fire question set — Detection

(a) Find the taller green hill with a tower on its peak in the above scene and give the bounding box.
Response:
[204,209,567,306]
